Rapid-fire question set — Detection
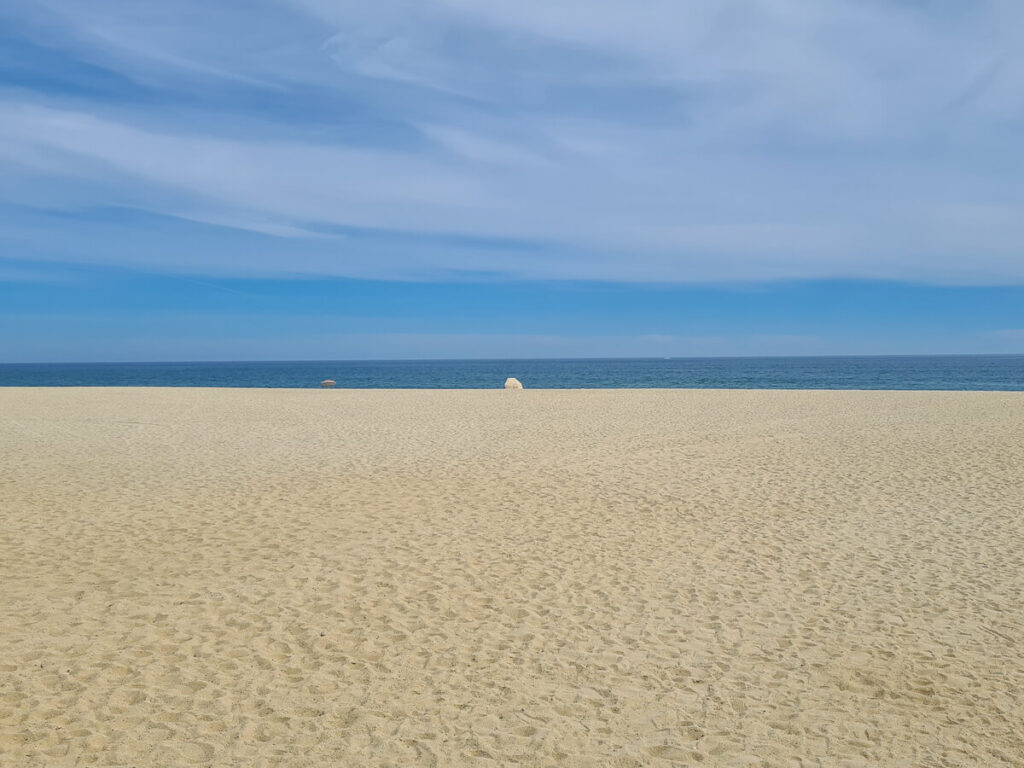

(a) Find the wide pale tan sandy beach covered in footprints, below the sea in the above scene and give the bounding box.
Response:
[0,391,1024,768]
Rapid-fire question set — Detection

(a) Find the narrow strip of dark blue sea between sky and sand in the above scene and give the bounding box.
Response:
[0,355,1024,390]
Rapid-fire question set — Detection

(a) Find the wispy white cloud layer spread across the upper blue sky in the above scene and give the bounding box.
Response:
[0,0,1024,283]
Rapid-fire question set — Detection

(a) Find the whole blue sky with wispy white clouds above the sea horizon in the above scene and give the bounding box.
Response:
[0,0,1024,362]
